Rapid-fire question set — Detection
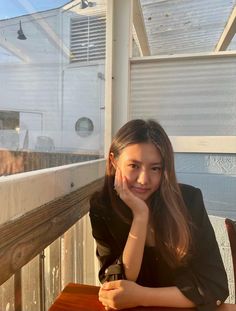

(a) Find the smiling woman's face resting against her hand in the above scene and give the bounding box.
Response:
[113,143,162,201]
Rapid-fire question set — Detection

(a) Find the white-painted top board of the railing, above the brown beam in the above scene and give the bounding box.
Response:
[0,159,105,225]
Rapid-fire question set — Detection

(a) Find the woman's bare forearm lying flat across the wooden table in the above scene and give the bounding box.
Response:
[140,286,195,308]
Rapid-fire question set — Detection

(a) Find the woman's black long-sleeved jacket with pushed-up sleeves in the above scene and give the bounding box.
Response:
[90,185,229,311]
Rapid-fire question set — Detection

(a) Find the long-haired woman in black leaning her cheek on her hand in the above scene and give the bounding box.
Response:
[90,120,228,311]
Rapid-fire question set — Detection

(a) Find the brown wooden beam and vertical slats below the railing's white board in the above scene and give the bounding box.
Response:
[0,179,102,311]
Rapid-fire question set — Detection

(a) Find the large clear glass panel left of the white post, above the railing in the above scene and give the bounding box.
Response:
[0,0,106,176]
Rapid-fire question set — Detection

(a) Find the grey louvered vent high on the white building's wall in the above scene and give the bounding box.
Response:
[70,16,106,62]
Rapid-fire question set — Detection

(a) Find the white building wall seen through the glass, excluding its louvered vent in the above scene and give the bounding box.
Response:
[0,9,104,154]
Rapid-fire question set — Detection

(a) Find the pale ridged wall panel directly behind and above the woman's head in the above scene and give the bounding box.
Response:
[130,55,236,136]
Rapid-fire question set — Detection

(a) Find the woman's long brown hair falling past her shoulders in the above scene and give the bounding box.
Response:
[97,119,191,268]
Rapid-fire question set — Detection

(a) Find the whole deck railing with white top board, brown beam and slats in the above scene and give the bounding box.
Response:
[0,160,104,311]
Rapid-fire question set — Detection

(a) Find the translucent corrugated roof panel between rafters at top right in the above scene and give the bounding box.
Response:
[141,0,236,55]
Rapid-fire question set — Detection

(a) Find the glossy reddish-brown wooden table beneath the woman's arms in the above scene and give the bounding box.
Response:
[48,283,236,311]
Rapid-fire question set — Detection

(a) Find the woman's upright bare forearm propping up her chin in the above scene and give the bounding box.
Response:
[122,213,148,281]
